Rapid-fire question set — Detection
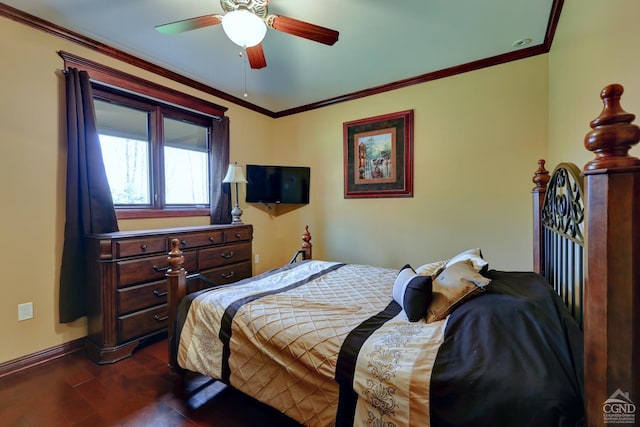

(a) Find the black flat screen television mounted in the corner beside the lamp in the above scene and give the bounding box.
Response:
[246,165,311,204]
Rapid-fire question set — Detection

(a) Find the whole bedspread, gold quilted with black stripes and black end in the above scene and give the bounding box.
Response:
[174,261,584,427]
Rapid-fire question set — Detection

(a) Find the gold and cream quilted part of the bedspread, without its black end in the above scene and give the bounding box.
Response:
[178,261,445,426]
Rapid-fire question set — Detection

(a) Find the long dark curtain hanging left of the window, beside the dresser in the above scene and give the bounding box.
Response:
[59,68,118,323]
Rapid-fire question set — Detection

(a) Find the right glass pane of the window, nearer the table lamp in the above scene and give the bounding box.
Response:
[163,117,209,205]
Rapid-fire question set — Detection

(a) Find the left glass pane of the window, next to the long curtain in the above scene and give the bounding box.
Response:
[94,99,151,206]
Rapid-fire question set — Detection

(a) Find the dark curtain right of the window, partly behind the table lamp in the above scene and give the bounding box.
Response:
[209,116,231,224]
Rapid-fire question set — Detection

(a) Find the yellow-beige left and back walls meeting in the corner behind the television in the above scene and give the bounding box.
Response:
[0,11,549,363]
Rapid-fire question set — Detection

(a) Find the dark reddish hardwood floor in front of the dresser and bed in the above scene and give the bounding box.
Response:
[0,340,299,427]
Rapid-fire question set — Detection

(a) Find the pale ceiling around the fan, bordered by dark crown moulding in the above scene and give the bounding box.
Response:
[3,0,561,113]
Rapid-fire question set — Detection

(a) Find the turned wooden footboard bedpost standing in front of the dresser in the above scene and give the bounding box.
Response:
[166,239,187,371]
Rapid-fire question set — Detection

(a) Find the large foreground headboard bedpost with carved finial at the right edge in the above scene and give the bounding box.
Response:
[583,84,640,426]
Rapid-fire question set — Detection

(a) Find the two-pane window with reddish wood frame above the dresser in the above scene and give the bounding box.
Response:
[93,84,215,218]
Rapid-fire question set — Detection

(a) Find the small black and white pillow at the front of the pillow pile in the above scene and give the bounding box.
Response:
[393,264,431,322]
